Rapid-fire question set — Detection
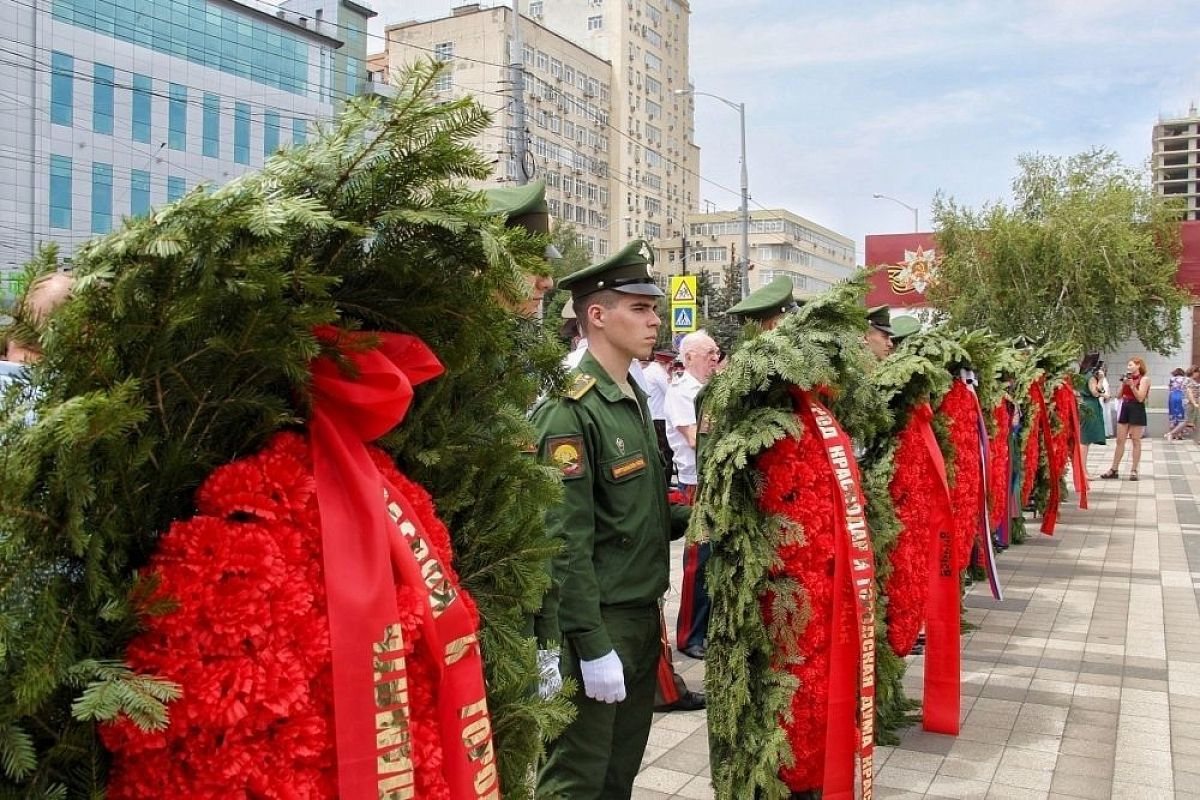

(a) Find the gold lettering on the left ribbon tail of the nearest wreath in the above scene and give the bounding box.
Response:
[372,622,416,800]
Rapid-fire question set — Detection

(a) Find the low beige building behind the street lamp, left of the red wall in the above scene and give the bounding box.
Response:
[654,209,856,297]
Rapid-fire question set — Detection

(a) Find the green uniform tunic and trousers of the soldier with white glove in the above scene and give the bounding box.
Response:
[532,353,671,800]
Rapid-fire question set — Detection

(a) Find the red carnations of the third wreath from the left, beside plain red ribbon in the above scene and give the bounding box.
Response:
[884,419,946,657]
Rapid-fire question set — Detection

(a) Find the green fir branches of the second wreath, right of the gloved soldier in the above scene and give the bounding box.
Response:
[689,276,890,799]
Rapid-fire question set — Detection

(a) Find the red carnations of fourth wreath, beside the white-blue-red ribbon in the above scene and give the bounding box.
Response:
[937,380,984,571]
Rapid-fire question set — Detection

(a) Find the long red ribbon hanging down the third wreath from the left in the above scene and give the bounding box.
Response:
[908,403,961,734]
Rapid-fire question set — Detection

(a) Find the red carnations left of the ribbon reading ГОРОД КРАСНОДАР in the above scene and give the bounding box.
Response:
[757,417,836,792]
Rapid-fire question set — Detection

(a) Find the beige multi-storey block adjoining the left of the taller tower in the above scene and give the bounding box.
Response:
[371,5,616,255]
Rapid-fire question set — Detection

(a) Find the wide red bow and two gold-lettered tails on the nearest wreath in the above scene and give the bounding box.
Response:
[308,326,499,800]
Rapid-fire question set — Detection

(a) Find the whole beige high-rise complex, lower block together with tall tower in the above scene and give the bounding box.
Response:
[388,0,700,255]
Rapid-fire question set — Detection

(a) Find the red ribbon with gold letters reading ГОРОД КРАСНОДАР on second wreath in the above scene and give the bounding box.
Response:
[792,386,875,800]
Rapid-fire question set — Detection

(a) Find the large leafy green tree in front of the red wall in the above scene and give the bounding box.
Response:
[928,149,1186,353]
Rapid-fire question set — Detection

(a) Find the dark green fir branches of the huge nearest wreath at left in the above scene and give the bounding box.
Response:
[0,65,569,798]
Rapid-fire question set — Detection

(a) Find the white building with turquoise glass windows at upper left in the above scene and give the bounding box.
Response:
[0,0,374,271]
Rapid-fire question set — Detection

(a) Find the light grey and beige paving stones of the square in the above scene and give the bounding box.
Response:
[634,438,1200,800]
